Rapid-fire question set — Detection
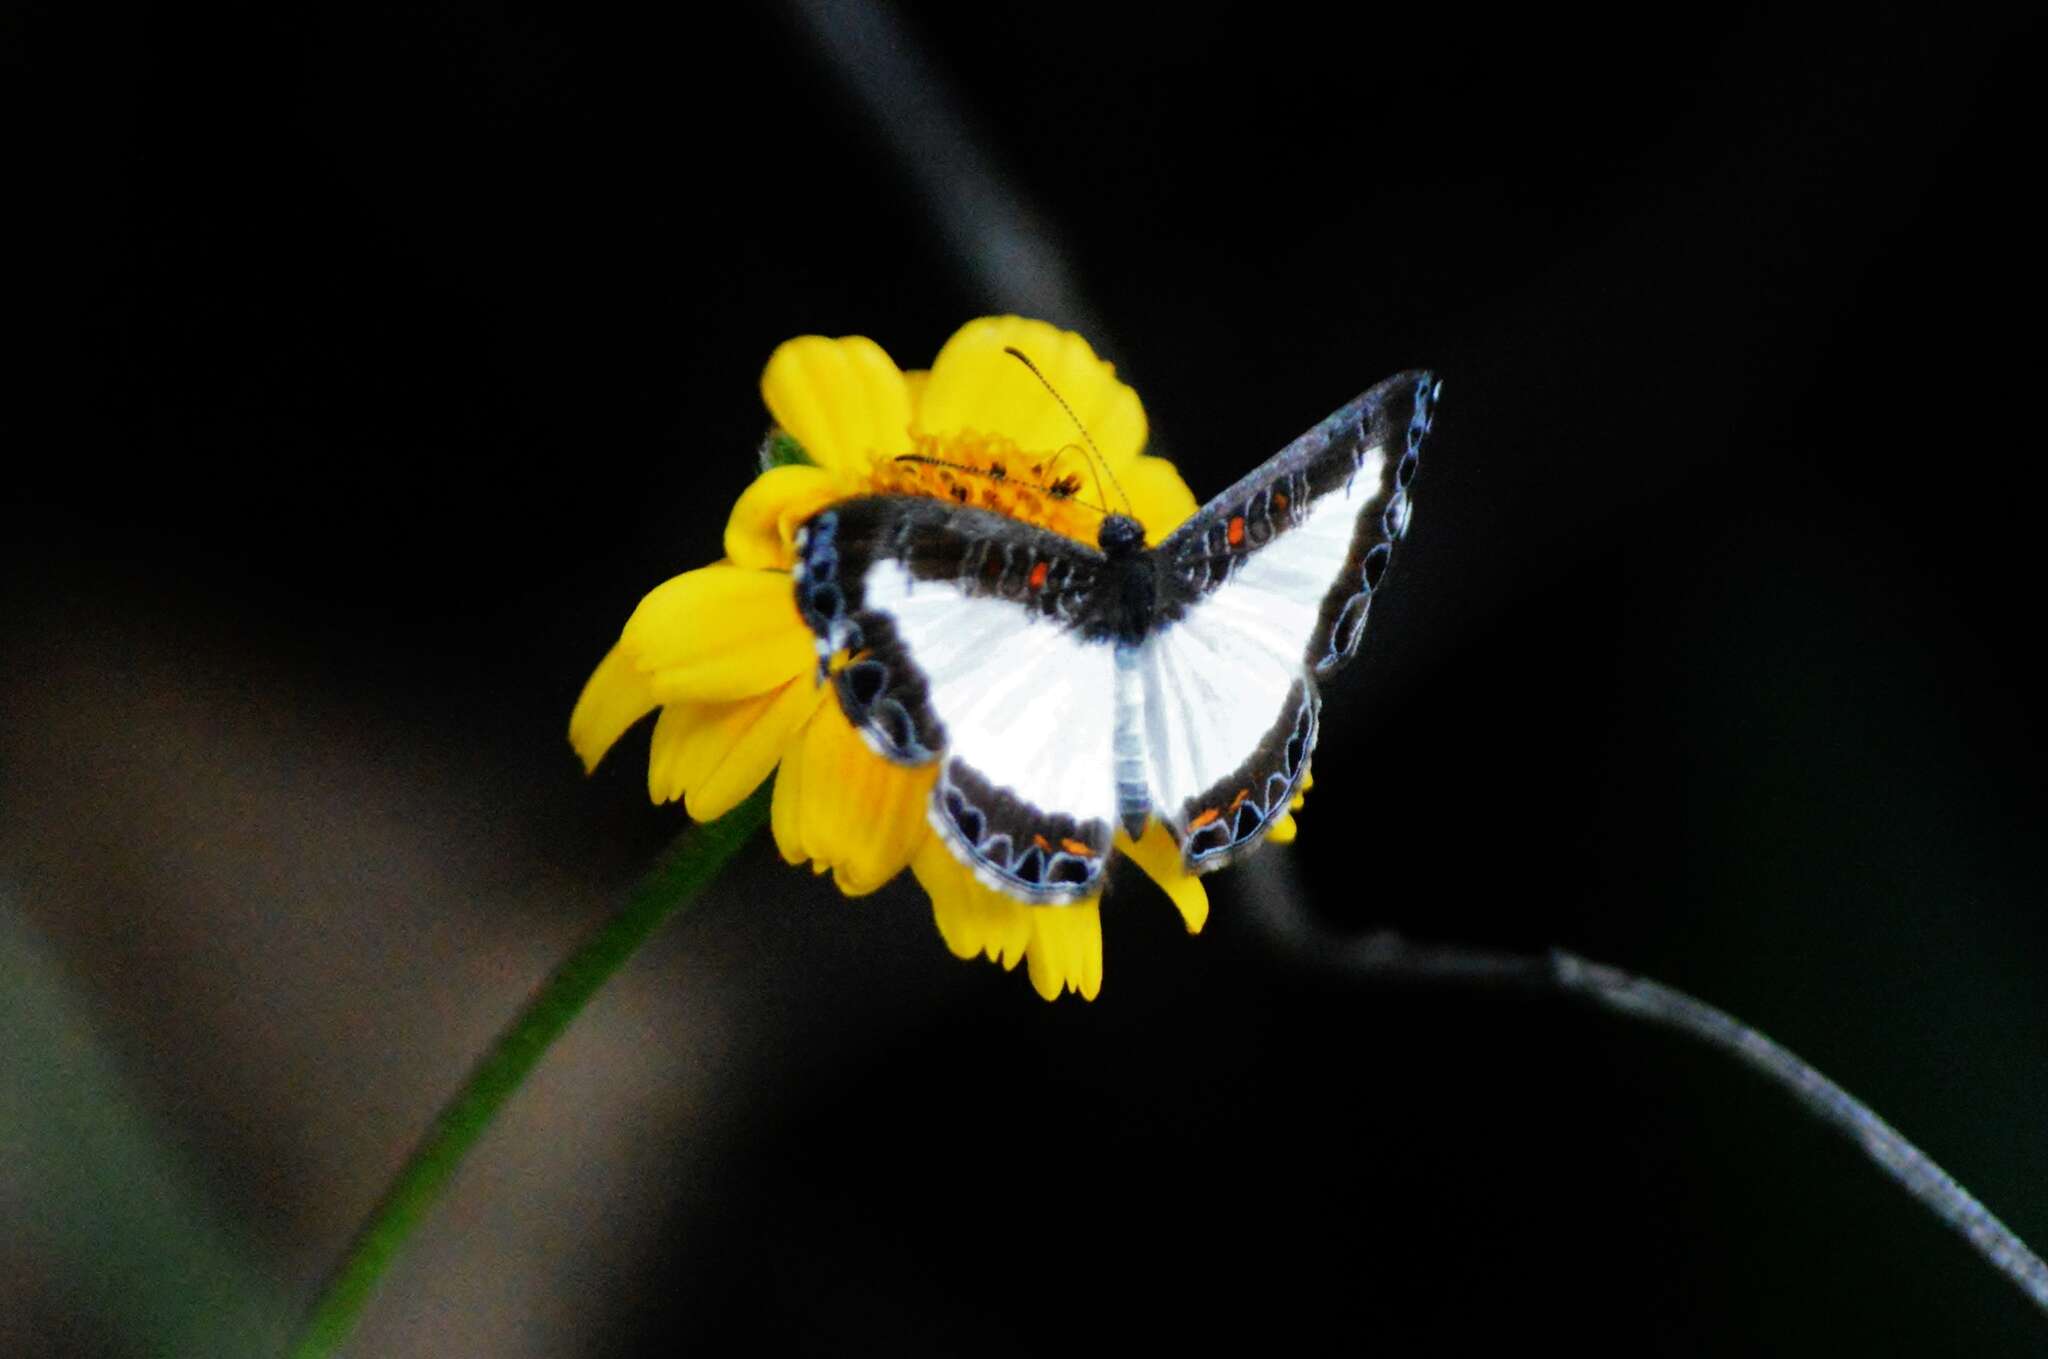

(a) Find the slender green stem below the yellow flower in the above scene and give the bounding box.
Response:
[291,784,770,1359]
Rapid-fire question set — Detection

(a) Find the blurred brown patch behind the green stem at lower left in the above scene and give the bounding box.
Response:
[0,568,937,1355]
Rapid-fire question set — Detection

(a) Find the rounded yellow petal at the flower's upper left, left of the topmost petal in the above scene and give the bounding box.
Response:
[762,336,913,471]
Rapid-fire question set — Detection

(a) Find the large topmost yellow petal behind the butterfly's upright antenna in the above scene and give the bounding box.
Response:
[918,315,1145,475]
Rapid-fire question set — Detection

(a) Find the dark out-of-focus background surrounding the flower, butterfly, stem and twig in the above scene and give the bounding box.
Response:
[0,0,2048,1355]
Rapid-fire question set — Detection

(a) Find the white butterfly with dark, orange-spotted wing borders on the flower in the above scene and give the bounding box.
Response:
[793,372,1442,905]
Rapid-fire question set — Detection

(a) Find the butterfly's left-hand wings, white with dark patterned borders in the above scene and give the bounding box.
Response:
[797,497,1116,903]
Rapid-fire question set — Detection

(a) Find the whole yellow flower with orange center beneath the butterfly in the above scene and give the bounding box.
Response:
[569,317,1298,999]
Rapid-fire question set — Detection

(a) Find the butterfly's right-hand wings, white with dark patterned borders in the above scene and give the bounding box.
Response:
[1135,372,1438,870]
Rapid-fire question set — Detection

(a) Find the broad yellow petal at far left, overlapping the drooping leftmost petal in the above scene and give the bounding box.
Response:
[618,563,817,704]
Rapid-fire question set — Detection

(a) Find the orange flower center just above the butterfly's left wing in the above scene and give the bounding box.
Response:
[870,430,1102,542]
